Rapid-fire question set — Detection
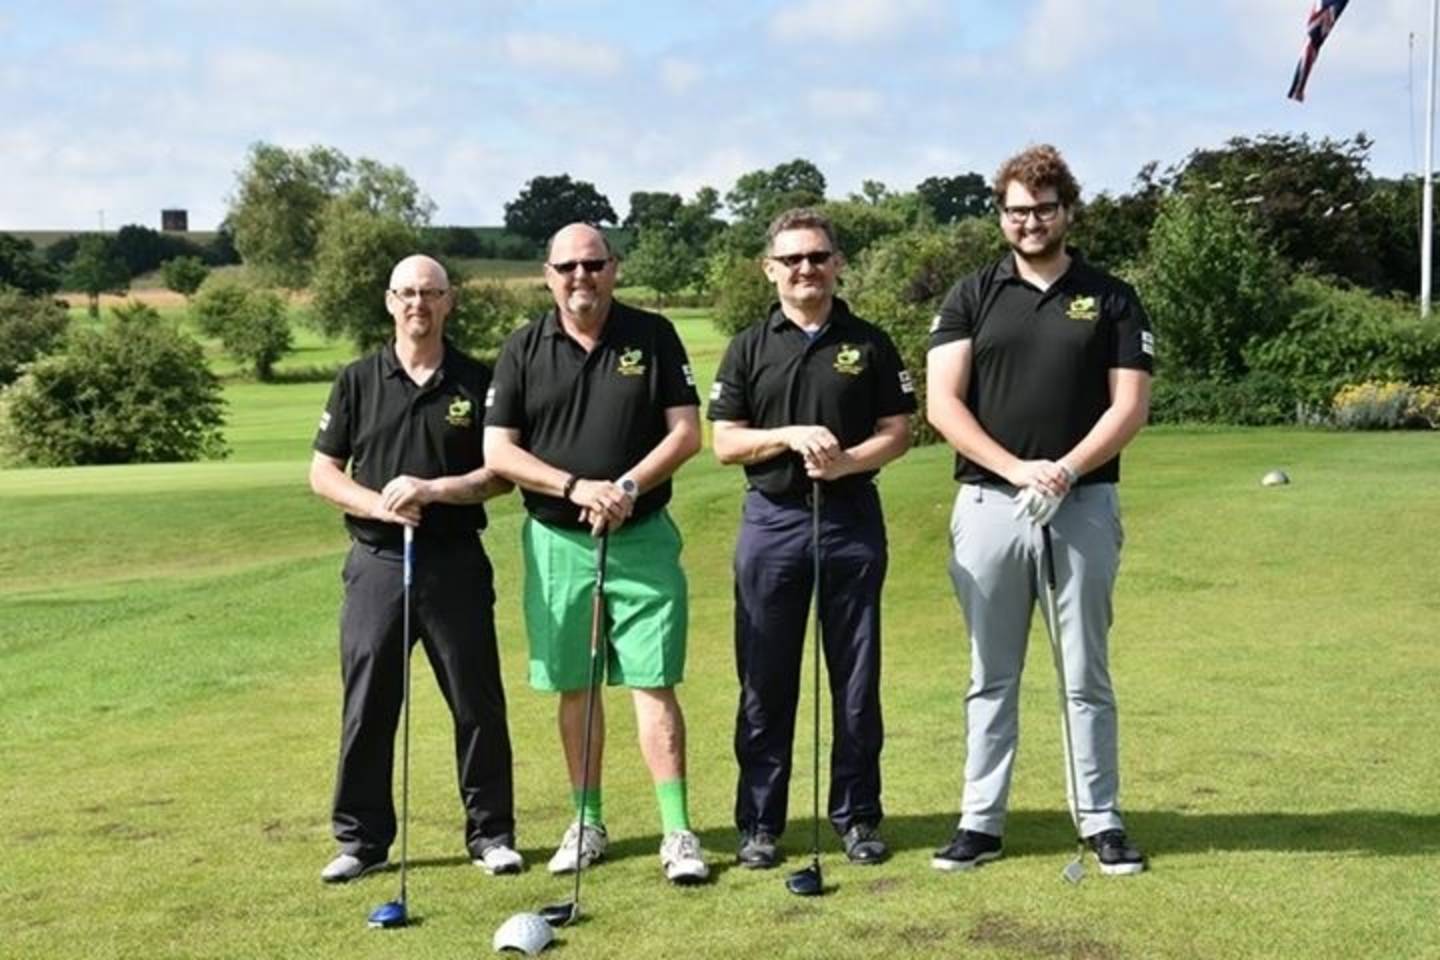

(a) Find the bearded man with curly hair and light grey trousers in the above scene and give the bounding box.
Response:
[926,145,1155,875]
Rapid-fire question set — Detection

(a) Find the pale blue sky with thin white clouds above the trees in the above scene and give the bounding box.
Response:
[0,0,1430,229]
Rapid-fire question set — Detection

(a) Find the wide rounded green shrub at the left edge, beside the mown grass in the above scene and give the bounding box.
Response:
[0,304,225,466]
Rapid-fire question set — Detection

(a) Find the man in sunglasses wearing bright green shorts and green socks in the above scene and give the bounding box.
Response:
[485,223,708,884]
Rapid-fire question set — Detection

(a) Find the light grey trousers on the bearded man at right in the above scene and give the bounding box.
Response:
[950,484,1125,836]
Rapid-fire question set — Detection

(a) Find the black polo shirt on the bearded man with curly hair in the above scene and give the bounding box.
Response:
[930,250,1155,484]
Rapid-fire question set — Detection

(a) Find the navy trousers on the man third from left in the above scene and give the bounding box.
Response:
[734,486,887,836]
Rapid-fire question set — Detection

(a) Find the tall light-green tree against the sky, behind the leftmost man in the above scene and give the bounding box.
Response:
[226,142,435,288]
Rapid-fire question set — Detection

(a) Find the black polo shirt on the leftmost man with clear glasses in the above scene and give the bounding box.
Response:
[314,340,490,548]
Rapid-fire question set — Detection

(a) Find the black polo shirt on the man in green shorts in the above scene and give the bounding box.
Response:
[485,302,700,528]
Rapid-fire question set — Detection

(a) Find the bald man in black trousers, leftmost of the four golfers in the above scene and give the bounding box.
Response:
[310,256,523,882]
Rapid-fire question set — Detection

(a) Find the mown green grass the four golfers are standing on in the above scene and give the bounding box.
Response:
[0,345,1440,960]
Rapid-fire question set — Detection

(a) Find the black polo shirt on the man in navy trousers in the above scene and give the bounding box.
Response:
[707,296,916,497]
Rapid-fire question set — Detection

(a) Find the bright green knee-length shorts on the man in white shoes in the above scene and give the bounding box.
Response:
[520,510,688,691]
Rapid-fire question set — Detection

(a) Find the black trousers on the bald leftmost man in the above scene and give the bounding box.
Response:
[331,537,516,859]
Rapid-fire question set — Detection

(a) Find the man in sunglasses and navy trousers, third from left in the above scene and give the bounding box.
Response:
[707,209,916,868]
